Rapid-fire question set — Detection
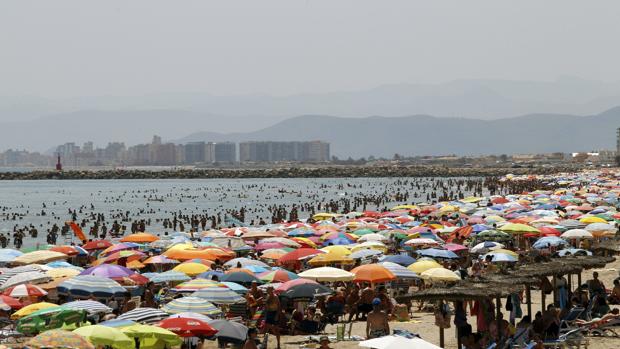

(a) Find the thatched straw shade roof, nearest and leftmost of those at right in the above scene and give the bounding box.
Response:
[412,282,523,301]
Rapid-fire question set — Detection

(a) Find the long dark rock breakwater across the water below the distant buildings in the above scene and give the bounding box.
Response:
[0,165,582,181]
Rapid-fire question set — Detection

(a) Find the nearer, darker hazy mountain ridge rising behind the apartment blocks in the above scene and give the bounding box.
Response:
[176,107,620,157]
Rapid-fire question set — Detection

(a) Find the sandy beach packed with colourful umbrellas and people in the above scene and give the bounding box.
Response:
[0,170,620,349]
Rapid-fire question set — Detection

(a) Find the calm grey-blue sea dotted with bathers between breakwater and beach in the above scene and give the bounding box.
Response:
[0,178,482,246]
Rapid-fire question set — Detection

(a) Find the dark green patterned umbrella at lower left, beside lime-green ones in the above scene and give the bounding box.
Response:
[17,306,86,334]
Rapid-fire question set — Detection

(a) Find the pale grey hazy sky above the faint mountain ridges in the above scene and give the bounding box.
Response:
[0,0,620,97]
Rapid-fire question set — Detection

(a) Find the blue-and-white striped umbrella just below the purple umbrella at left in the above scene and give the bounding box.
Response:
[58,275,127,298]
